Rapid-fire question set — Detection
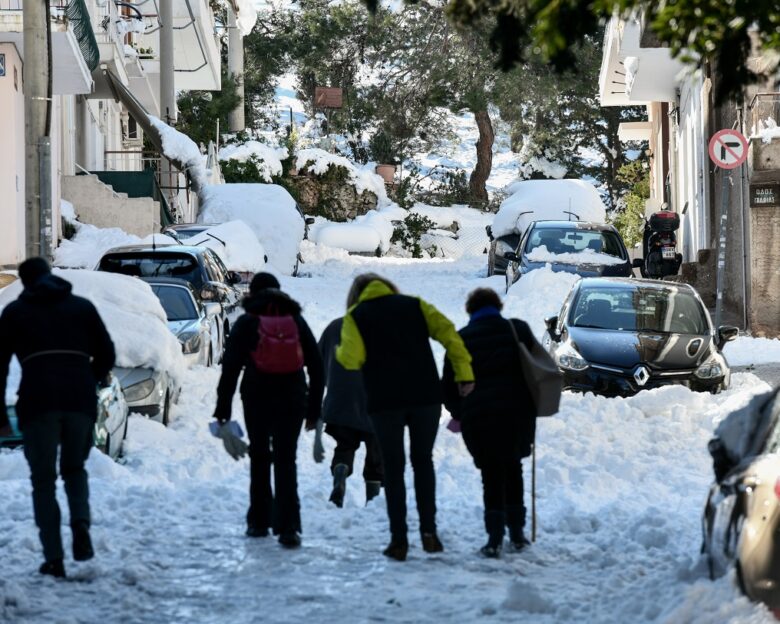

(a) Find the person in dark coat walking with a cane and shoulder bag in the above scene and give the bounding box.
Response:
[443,288,536,557]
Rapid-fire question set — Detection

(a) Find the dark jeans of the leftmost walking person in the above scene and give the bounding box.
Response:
[22,412,95,561]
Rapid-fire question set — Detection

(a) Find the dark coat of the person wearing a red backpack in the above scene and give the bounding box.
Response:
[214,288,324,421]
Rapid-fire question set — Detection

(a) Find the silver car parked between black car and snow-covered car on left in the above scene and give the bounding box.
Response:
[142,277,224,366]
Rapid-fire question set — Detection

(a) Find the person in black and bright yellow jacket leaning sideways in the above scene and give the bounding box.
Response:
[336,273,474,561]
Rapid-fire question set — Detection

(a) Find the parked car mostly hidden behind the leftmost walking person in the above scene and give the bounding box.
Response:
[0,375,128,459]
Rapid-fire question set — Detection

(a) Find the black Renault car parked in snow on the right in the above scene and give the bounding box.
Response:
[542,278,738,396]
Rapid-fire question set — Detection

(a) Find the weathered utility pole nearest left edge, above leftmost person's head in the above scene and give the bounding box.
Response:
[22,0,52,258]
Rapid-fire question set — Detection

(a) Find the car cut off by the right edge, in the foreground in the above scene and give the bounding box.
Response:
[702,388,780,616]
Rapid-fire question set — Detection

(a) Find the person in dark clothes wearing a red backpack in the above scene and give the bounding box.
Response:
[214,273,324,548]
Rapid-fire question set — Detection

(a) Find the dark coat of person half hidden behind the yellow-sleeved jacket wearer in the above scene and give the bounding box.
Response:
[319,318,371,431]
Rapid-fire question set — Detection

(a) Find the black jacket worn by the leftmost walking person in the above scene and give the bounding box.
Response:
[0,275,115,428]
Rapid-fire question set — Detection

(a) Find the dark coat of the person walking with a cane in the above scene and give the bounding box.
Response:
[443,313,536,466]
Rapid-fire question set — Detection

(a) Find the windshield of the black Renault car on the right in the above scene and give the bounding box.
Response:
[569,286,709,335]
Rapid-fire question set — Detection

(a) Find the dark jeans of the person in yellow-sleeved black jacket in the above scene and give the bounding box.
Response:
[370,405,441,542]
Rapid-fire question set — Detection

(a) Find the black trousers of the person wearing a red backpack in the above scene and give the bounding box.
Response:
[244,401,303,534]
